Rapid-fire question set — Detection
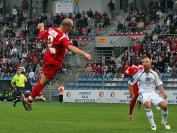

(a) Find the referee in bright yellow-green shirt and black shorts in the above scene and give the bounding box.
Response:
[11,67,27,107]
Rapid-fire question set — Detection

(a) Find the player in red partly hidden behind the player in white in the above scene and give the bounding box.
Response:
[124,58,143,119]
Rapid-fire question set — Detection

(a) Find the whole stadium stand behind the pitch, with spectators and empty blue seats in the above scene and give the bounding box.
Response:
[0,0,177,101]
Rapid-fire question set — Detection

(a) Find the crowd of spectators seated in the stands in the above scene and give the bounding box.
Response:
[0,0,177,80]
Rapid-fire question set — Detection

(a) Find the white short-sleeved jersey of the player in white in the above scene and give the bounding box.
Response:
[128,69,163,94]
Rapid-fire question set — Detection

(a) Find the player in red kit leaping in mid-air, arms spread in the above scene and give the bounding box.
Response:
[21,18,91,110]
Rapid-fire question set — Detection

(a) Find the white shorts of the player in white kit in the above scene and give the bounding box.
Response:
[139,92,165,106]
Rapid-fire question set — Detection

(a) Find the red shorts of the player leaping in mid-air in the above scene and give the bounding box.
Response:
[42,55,61,80]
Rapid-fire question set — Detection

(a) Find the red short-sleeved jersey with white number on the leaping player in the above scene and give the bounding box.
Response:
[38,28,71,62]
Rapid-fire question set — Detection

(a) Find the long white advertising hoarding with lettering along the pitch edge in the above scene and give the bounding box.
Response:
[64,89,177,104]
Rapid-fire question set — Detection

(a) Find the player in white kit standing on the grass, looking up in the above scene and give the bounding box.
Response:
[128,57,171,130]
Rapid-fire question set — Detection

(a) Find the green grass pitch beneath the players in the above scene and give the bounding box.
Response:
[0,102,177,133]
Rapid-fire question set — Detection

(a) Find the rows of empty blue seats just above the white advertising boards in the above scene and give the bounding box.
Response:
[63,73,177,89]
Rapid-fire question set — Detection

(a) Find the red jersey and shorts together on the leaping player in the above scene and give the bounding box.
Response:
[38,28,71,80]
